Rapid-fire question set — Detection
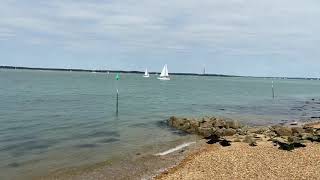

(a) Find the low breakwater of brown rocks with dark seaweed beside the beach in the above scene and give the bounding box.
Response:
[168,116,320,151]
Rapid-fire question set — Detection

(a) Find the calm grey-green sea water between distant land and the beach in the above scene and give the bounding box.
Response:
[0,70,320,179]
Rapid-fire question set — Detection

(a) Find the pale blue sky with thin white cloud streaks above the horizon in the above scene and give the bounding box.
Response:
[0,0,320,77]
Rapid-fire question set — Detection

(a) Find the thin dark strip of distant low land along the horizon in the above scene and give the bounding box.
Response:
[0,66,320,80]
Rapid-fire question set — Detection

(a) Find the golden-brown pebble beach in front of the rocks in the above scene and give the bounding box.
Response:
[156,141,320,180]
